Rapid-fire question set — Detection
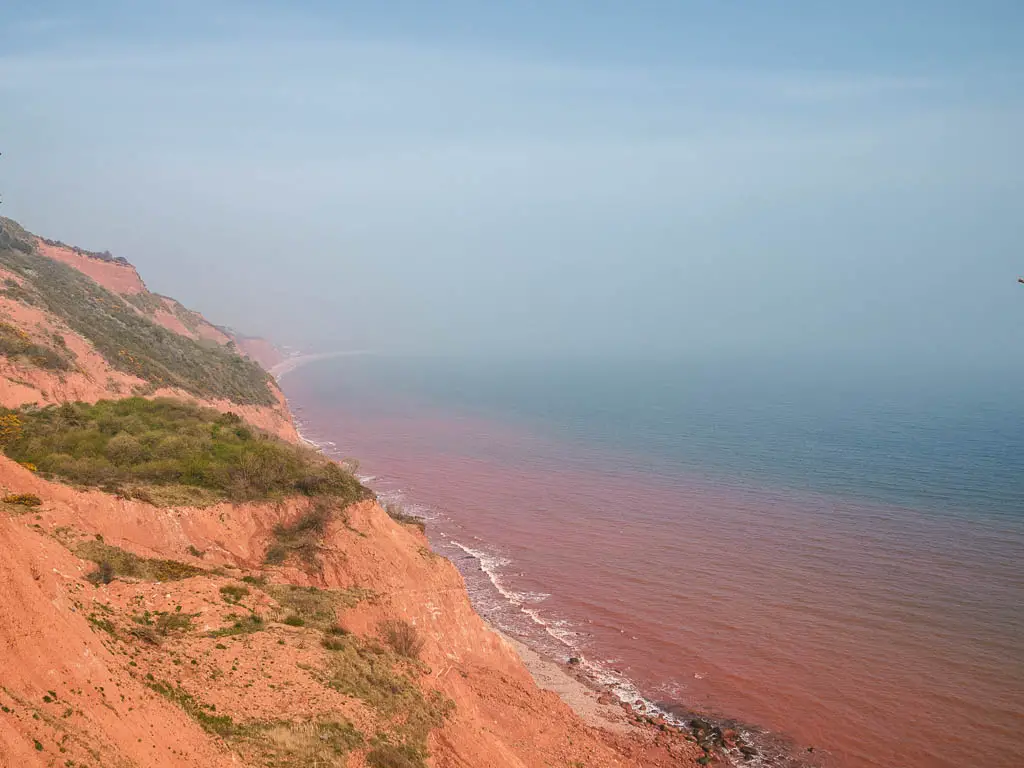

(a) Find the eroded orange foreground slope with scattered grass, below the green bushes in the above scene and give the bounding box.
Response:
[0,450,701,768]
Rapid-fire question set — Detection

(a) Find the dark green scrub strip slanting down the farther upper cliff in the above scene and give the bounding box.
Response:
[0,218,275,406]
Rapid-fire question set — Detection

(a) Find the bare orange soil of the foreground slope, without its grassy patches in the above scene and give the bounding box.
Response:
[0,459,699,768]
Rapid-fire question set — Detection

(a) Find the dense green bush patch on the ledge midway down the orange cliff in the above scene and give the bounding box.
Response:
[3,397,371,506]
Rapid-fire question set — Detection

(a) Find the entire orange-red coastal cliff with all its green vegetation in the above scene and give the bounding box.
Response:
[0,220,713,768]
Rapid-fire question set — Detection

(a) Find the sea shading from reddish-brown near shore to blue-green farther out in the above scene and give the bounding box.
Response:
[282,354,1024,768]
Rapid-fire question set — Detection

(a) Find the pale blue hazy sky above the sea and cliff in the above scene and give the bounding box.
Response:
[0,0,1024,366]
